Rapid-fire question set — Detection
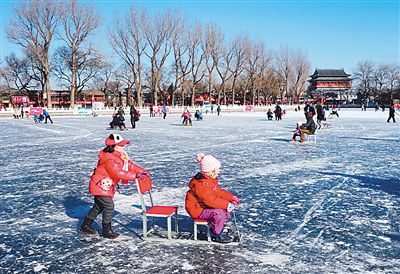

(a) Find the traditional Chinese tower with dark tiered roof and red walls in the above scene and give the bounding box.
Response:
[308,69,351,101]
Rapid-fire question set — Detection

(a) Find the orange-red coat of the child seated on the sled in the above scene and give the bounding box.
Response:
[185,173,233,218]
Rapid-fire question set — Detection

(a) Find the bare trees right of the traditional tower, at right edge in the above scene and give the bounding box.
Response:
[353,61,400,99]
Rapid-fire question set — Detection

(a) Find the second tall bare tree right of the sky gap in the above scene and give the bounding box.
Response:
[144,12,175,105]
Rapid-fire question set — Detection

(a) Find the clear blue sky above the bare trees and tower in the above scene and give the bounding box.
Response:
[0,0,400,72]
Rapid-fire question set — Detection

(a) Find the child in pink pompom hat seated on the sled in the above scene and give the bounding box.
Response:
[185,153,240,243]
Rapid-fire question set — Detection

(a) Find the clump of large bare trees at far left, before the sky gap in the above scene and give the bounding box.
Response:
[1,0,101,107]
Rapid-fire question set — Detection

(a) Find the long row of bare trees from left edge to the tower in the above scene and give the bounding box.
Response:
[1,0,310,107]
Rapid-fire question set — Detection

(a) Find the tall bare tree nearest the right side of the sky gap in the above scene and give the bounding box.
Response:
[109,7,148,106]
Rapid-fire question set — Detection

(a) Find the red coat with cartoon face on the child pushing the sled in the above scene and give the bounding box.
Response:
[89,151,146,198]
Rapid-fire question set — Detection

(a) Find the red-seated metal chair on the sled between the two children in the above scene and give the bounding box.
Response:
[136,176,178,240]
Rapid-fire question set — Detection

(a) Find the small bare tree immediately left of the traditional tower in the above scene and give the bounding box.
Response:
[289,50,310,103]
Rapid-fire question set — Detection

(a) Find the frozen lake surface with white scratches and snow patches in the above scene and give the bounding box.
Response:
[0,111,400,273]
